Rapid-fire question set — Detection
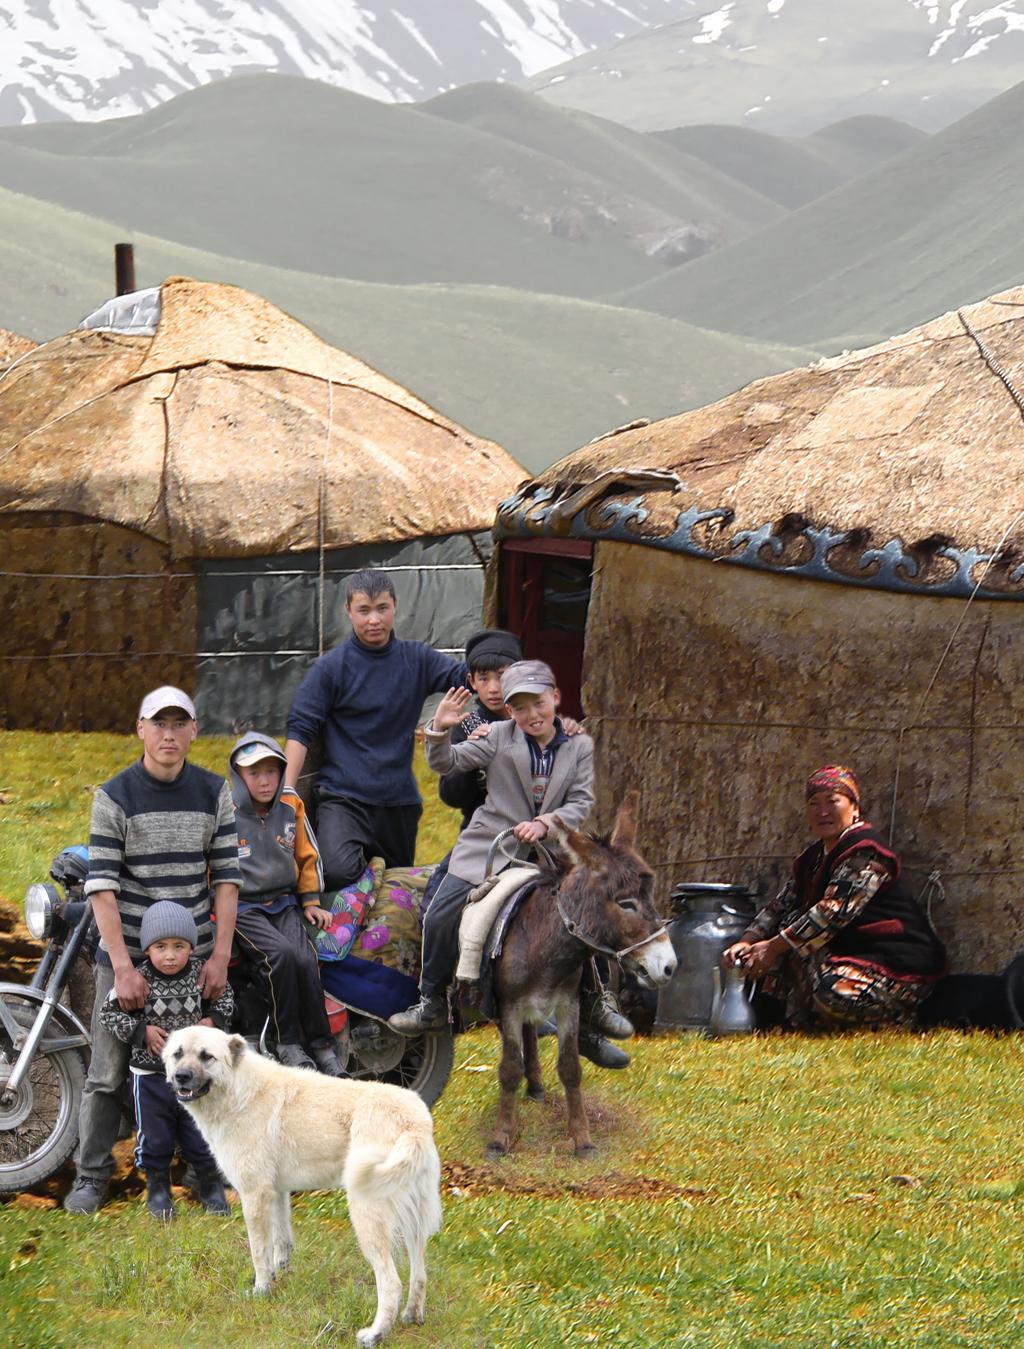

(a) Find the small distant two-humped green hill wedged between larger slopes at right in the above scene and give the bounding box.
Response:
[653,117,926,207]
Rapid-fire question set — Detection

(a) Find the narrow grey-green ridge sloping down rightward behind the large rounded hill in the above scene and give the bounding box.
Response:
[418,84,781,239]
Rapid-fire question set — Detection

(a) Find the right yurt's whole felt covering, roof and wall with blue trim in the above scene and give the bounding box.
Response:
[488,287,1024,970]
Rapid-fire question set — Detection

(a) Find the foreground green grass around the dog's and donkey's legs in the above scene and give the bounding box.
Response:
[0,1029,1024,1349]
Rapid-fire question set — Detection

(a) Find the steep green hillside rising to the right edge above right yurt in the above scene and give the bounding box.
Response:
[621,75,1024,349]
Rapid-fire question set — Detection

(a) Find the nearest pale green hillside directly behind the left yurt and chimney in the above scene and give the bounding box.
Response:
[0,182,812,469]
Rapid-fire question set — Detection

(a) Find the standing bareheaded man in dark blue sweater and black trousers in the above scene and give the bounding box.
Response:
[285,571,465,890]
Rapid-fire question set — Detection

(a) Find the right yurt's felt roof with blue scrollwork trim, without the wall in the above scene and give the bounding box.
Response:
[496,286,1024,598]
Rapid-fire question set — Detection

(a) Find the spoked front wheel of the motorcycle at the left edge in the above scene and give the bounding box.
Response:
[0,994,85,1194]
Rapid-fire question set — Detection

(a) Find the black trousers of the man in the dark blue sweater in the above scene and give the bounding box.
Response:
[317,796,424,890]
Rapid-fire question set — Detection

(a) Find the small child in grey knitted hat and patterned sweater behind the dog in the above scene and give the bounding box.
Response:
[100,900,233,1221]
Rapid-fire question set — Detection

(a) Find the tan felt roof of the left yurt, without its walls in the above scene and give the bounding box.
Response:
[0,277,526,557]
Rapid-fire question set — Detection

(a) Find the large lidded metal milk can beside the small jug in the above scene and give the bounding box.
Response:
[654,881,754,1029]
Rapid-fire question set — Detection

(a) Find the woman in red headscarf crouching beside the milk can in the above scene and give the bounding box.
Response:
[722,764,946,1025]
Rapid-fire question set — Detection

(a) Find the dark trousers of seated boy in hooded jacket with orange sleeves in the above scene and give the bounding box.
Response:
[235,904,331,1044]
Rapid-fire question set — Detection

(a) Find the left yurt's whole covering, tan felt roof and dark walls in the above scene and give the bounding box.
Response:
[0,278,525,731]
